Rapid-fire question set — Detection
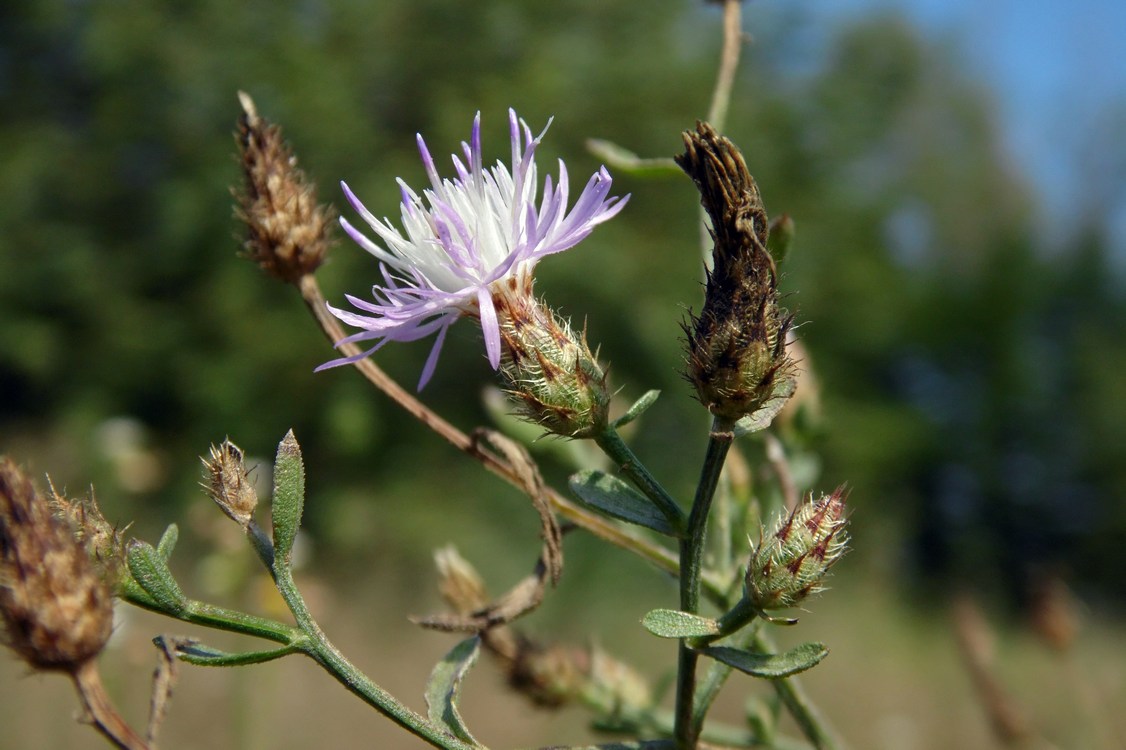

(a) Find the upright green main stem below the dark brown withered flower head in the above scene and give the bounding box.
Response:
[674,417,735,750]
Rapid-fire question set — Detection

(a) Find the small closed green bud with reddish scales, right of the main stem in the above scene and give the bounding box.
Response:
[744,486,848,611]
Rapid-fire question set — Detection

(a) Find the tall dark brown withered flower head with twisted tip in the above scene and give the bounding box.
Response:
[677,123,797,421]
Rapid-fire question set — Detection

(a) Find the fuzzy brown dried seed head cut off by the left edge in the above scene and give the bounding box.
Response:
[0,458,114,673]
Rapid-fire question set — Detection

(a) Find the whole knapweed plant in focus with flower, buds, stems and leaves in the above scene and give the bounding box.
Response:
[0,2,847,750]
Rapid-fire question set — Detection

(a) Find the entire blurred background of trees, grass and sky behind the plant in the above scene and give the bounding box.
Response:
[0,0,1126,748]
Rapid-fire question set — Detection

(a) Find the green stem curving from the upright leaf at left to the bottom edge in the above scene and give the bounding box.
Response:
[274,563,473,750]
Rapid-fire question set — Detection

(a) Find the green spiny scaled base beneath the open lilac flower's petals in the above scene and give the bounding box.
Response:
[493,287,610,438]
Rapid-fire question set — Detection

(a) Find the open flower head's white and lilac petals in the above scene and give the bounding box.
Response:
[318,109,629,390]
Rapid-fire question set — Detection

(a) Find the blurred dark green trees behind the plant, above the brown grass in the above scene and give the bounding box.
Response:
[0,0,1126,599]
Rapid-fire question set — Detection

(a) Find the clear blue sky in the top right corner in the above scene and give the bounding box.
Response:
[819,0,1126,254]
